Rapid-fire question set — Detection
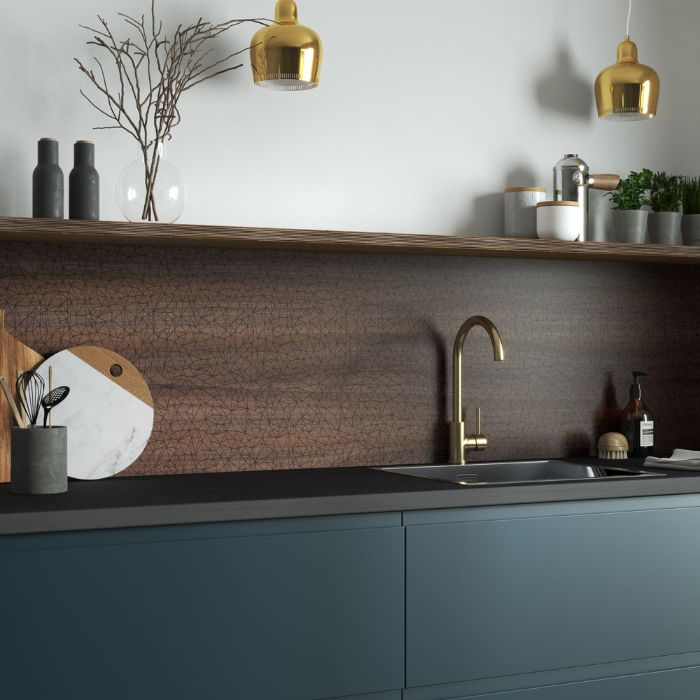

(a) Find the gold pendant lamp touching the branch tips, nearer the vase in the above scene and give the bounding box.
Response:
[250,0,322,90]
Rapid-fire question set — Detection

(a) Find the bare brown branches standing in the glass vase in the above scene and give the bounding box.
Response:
[75,0,269,221]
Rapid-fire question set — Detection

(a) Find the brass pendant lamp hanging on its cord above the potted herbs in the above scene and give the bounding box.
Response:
[595,0,659,121]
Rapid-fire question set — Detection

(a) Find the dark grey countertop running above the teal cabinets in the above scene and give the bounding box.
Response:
[0,460,700,535]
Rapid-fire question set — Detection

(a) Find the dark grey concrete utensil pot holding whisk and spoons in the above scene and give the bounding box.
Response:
[10,426,68,494]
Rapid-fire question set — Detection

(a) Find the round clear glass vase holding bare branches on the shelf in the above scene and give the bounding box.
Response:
[117,142,185,224]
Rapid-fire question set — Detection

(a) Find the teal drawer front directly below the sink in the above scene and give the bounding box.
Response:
[406,499,700,687]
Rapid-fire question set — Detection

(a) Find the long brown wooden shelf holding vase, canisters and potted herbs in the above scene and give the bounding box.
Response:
[0,218,700,264]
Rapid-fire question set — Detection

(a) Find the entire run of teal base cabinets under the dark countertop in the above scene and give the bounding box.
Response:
[8,495,700,700]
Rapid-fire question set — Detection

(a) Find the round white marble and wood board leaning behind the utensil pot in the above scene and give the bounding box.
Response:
[37,346,153,479]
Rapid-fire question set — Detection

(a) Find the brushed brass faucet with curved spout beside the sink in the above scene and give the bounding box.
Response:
[450,316,505,464]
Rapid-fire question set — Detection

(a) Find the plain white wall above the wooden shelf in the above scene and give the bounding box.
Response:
[0,0,700,235]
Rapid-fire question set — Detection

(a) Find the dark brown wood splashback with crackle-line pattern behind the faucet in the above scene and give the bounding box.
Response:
[0,242,700,475]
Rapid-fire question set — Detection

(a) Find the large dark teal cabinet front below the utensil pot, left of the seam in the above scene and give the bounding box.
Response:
[0,516,404,700]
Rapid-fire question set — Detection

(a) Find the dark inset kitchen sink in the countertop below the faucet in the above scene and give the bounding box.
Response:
[376,459,666,486]
